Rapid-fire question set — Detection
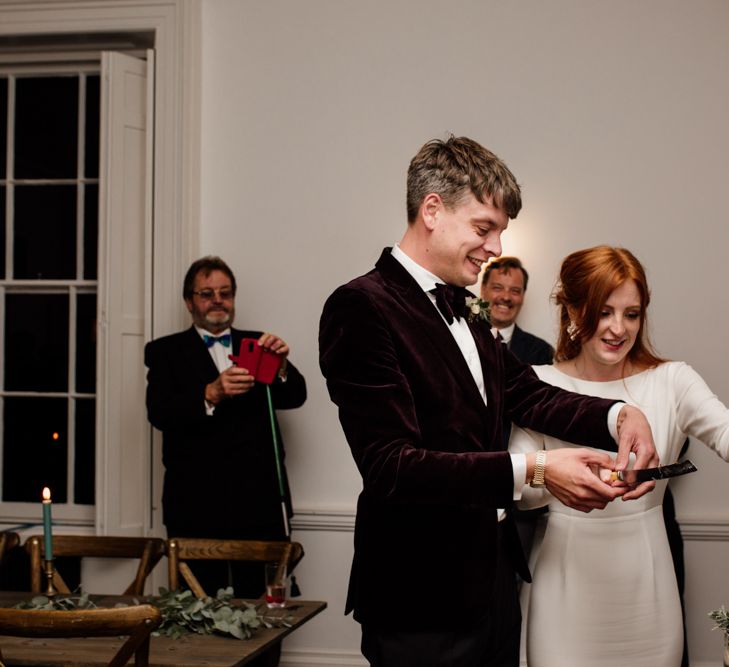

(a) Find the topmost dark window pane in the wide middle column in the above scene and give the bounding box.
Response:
[15,76,78,178]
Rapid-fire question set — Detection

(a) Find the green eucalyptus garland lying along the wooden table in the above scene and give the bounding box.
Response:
[16,587,292,639]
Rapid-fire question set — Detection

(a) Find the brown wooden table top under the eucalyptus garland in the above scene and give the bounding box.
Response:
[0,592,327,667]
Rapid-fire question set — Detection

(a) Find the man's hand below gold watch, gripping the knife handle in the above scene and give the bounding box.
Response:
[527,448,626,512]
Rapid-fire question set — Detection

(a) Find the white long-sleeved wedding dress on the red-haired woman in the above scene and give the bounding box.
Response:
[509,362,729,667]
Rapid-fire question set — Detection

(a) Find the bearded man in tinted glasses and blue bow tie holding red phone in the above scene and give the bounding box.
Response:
[144,256,306,612]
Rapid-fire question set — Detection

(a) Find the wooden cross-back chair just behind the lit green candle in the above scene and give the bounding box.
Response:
[25,535,165,595]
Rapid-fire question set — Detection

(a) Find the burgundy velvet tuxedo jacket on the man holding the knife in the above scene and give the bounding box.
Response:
[319,249,616,630]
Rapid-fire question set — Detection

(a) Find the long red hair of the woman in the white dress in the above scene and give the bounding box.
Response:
[552,245,665,368]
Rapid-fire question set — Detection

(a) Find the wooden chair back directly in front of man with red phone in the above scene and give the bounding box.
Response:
[167,537,304,598]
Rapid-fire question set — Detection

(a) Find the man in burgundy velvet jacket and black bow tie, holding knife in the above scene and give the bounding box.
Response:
[319,137,656,667]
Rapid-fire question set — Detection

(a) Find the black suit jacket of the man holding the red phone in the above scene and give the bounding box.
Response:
[144,327,306,539]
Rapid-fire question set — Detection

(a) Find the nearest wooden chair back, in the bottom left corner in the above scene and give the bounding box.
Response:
[0,604,162,667]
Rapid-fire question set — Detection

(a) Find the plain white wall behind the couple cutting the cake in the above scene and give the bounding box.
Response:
[200,0,729,664]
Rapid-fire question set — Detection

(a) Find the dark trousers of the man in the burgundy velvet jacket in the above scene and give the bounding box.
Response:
[362,527,521,667]
